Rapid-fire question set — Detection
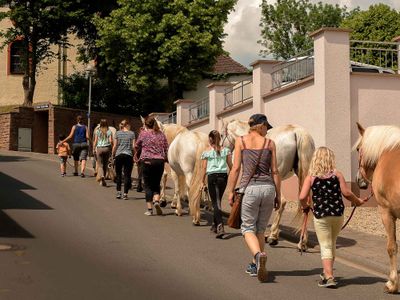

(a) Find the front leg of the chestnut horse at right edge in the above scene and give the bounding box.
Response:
[380,208,399,294]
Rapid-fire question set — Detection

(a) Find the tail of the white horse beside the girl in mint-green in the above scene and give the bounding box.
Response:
[189,132,206,216]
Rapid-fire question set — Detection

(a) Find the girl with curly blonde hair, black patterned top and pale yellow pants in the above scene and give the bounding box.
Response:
[299,147,367,288]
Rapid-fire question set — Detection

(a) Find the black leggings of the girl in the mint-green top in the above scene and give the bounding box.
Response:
[207,173,228,225]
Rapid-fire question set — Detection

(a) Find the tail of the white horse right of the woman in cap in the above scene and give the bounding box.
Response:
[294,127,315,233]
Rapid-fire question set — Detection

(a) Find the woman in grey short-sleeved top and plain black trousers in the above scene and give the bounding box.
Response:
[112,120,135,200]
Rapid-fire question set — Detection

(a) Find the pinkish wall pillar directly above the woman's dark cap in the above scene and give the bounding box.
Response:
[250,60,279,114]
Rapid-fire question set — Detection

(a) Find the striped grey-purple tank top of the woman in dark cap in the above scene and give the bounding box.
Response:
[240,138,274,188]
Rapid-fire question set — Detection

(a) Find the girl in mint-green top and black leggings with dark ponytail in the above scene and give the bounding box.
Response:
[201,130,232,238]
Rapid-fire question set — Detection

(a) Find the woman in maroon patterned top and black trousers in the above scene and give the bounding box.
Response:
[135,116,168,216]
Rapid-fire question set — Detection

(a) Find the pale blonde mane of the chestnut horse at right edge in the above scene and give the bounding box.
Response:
[355,126,400,168]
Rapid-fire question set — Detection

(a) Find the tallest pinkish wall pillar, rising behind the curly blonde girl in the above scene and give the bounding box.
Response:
[310,28,353,180]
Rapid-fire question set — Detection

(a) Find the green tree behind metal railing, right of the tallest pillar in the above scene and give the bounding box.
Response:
[341,4,400,69]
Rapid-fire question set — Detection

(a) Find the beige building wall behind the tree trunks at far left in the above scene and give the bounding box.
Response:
[0,9,84,106]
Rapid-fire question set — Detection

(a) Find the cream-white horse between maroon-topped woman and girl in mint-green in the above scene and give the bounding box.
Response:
[168,131,208,225]
